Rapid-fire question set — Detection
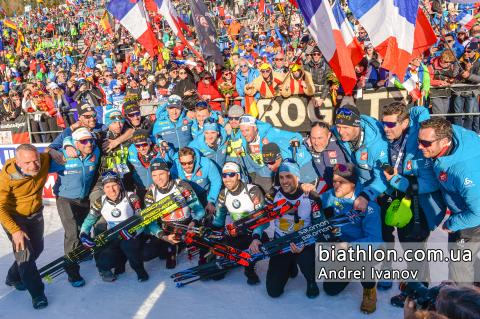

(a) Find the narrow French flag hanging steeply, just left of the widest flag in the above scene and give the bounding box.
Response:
[296,0,357,94]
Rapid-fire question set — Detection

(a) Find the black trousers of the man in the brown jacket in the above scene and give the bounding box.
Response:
[3,210,45,298]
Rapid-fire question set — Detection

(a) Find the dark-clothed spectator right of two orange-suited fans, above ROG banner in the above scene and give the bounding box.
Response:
[305,46,331,107]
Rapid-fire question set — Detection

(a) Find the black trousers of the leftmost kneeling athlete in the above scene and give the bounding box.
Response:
[96,236,144,271]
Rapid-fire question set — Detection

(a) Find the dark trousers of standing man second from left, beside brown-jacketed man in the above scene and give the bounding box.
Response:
[57,196,90,276]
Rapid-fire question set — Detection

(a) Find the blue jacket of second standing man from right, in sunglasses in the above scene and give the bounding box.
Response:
[387,106,446,231]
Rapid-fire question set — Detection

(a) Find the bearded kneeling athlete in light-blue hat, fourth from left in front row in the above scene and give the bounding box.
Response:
[265,162,325,299]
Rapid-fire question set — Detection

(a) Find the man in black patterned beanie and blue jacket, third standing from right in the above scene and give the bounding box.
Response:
[333,104,388,212]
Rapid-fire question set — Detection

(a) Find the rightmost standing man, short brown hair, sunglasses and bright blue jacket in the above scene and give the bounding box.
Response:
[418,117,480,285]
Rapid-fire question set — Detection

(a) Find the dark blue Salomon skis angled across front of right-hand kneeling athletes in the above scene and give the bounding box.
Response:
[171,211,365,287]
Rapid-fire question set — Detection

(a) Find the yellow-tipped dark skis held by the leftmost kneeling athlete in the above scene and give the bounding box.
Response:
[39,193,185,281]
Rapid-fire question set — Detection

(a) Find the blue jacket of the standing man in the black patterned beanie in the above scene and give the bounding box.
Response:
[333,115,388,200]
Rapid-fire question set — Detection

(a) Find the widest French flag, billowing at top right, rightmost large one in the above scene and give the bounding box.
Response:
[348,0,437,82]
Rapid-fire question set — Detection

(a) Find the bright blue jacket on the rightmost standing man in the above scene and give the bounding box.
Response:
[433,125,480,232]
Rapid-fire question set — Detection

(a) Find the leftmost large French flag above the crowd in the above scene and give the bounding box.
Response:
[107,0,158,56]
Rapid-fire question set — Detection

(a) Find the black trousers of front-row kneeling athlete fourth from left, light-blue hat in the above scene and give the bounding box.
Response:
[267,245,315,298]
